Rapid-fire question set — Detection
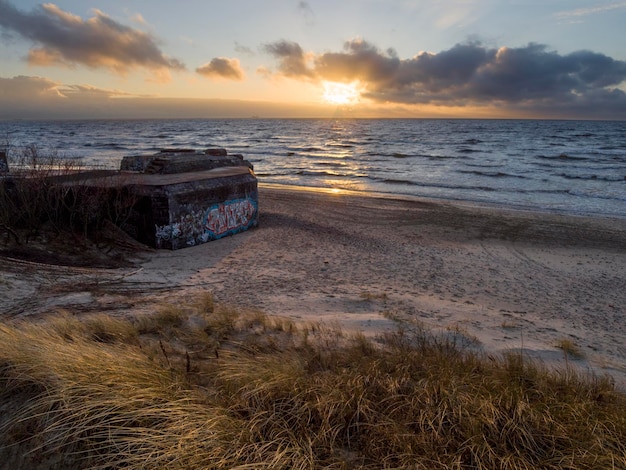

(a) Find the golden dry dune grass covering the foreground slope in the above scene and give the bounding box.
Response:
[0,296,626,469]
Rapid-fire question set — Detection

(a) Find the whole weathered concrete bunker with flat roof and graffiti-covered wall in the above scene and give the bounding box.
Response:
[0,149,259,250]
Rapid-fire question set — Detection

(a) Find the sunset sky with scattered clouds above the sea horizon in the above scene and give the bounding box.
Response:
[0,0,626,120]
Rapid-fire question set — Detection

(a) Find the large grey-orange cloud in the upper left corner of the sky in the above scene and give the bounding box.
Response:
[0,0,185,74]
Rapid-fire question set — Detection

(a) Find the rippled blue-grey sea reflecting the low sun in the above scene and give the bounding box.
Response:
[0,118,626,218]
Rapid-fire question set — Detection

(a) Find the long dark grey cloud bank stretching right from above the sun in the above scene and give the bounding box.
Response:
[264,39,626,117]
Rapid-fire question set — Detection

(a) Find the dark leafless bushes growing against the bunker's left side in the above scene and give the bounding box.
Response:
[0,144,135,250]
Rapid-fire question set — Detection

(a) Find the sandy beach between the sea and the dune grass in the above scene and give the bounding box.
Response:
[0,185,626,389]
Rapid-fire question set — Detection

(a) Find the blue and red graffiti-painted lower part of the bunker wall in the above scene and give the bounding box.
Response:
[155,197,258,249]
